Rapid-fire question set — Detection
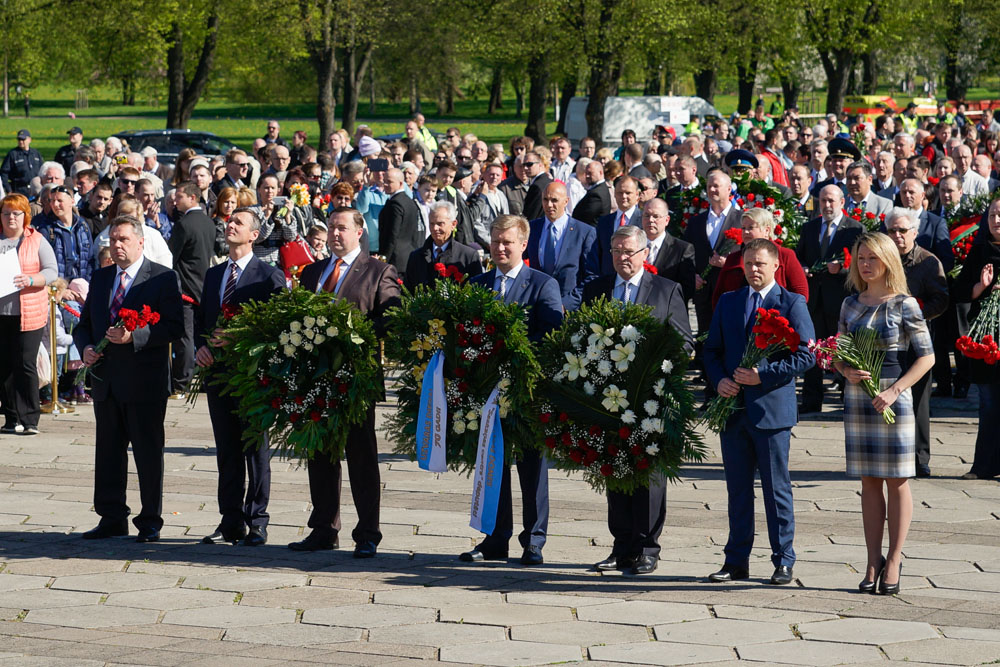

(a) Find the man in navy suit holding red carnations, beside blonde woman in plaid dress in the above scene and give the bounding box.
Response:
[704,239,815,585]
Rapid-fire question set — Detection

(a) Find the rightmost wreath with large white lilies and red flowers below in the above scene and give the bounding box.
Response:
[534,297,705,493]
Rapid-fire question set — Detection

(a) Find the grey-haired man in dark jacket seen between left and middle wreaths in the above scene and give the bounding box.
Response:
[404,200,483,290]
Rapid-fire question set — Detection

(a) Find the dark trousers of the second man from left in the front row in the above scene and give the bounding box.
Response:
[205,387,271,533]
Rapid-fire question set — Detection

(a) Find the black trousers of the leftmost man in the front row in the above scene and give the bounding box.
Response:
[94,395,167,530]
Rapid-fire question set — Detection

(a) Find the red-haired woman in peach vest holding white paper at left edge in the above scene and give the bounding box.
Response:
[0,194,59,435]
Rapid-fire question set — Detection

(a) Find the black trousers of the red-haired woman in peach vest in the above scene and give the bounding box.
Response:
[0,315,45,427]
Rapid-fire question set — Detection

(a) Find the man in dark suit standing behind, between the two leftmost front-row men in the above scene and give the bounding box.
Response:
[167,183,215,397]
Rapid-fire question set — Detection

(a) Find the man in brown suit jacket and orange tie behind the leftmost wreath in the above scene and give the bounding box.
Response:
[288,207,399,558]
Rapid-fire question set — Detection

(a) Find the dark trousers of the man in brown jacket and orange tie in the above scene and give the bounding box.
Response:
[309,405,382,544]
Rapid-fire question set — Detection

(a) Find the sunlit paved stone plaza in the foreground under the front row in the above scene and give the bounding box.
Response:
[0,380,1000,666]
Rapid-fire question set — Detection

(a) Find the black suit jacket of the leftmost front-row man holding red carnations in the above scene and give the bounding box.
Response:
[73,258,186,403]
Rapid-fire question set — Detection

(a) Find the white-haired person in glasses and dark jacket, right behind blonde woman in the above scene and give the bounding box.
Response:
[886,208,948,477]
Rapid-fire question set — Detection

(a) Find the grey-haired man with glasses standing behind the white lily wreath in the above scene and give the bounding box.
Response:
[584,227,694,574]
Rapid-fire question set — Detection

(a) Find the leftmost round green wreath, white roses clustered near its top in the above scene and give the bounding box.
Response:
[212,287,384,459]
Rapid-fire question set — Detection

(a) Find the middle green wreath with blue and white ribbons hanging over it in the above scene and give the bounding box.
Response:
[385,276,540,471]
